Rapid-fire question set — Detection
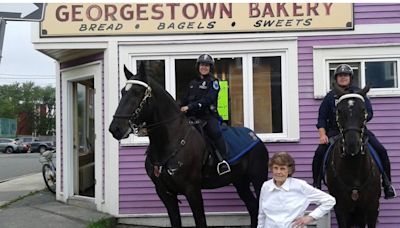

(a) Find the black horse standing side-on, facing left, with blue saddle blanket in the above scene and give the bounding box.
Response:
[109,67,269,227]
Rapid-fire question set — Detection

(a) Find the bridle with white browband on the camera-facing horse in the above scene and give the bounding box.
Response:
[336,93,368,157]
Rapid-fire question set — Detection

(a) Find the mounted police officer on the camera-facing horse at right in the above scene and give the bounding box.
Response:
[312,64,396,199]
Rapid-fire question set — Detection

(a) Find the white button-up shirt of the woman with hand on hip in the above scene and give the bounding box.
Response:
[257,177,336,228]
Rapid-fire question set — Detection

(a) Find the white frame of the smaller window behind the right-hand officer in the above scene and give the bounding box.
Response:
[313,44,400,99]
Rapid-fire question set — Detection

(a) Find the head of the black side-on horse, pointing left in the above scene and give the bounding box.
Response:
[109,64,152,140]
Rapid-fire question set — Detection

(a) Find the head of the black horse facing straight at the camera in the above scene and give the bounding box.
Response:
[334,86,369,157]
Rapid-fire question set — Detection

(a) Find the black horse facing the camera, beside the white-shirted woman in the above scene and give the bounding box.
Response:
[327,86,381,228]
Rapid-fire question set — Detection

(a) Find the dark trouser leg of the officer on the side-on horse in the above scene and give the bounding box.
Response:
[204,116,226,159]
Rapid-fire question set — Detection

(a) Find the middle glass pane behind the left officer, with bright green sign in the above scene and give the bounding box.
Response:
[175,58,244,126]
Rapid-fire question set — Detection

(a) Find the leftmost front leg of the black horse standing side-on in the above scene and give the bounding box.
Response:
[156,185,182,228]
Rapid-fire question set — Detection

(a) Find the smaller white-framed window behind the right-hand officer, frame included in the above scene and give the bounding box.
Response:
[314,46,400,98]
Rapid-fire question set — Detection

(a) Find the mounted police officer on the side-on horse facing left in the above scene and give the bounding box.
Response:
[181,54,230,175]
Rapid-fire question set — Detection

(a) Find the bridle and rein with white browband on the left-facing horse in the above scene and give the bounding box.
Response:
[113,79,182,136]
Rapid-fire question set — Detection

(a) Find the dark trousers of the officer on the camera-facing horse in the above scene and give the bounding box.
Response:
[312,130,391,185]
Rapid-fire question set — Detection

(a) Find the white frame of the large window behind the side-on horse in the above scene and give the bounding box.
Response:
[119,38,300,146]
